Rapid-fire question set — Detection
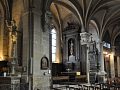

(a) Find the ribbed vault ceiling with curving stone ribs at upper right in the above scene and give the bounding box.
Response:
[50,0,120,43]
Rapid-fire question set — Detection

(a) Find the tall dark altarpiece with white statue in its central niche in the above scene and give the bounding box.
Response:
[63,22,80,71]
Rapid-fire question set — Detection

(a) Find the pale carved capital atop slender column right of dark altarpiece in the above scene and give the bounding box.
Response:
[80,32,91,45]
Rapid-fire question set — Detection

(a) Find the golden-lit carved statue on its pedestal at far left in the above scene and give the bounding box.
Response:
[6,20,18,75]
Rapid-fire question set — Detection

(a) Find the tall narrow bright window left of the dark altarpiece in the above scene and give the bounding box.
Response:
[51,28,56,62]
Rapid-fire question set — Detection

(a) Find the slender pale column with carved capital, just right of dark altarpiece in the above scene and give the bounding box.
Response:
[80,32,91,83]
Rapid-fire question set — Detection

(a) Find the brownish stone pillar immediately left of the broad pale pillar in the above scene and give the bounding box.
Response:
[21,0,34,90]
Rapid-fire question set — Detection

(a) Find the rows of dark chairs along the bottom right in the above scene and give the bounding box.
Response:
[52,78,120,90]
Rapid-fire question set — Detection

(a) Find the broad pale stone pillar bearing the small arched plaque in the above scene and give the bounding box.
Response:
[33,11,52,90]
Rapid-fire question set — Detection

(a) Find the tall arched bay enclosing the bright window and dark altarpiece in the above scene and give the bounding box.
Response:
[50,1,85,83]
